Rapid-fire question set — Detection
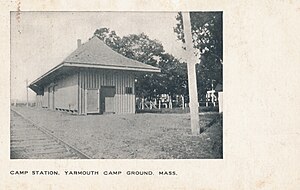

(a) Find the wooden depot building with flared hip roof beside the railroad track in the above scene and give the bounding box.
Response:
[29,36,160,115]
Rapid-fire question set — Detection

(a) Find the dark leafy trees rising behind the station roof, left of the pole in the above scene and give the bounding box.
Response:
[94,28,187,98]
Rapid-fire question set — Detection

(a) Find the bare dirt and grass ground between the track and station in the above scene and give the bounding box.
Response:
[13,107,223,159]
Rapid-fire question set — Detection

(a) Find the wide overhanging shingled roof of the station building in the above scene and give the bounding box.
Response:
[29,36,160,92]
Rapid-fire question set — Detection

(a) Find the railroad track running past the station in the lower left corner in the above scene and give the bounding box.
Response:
[10,109,91,159]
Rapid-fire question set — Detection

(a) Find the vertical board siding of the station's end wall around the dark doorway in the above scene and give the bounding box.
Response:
[79,70,135,114]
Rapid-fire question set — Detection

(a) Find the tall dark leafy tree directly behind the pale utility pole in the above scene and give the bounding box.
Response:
[174,12,223,99]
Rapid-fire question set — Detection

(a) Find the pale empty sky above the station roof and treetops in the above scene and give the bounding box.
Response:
[10,12,182,101]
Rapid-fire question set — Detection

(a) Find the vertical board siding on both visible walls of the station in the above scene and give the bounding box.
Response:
[37,70,135,114]
